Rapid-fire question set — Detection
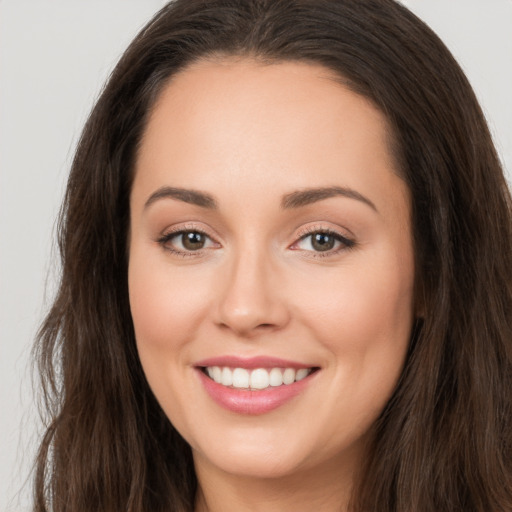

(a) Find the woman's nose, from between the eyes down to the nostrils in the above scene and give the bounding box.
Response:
[216,250,290,338]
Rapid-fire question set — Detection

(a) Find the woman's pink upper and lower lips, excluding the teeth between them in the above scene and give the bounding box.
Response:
[195,356,317,415]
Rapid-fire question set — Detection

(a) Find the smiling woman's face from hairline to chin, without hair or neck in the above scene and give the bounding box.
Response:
[129,58,414,477]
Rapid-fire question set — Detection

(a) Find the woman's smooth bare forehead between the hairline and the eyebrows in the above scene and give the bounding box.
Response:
[134,58,408,218]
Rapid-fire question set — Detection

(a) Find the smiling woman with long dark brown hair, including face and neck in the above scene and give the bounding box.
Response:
[36,0,512,512]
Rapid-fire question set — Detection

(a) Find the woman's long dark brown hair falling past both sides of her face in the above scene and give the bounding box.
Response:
[34,0,512,512]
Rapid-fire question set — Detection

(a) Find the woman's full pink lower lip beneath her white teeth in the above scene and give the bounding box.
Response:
[197,369,317,415]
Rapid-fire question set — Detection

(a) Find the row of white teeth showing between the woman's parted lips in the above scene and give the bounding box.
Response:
[200,366,319,391]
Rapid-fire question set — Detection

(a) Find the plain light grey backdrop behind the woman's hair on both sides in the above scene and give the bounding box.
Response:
[0,0,512,512]
